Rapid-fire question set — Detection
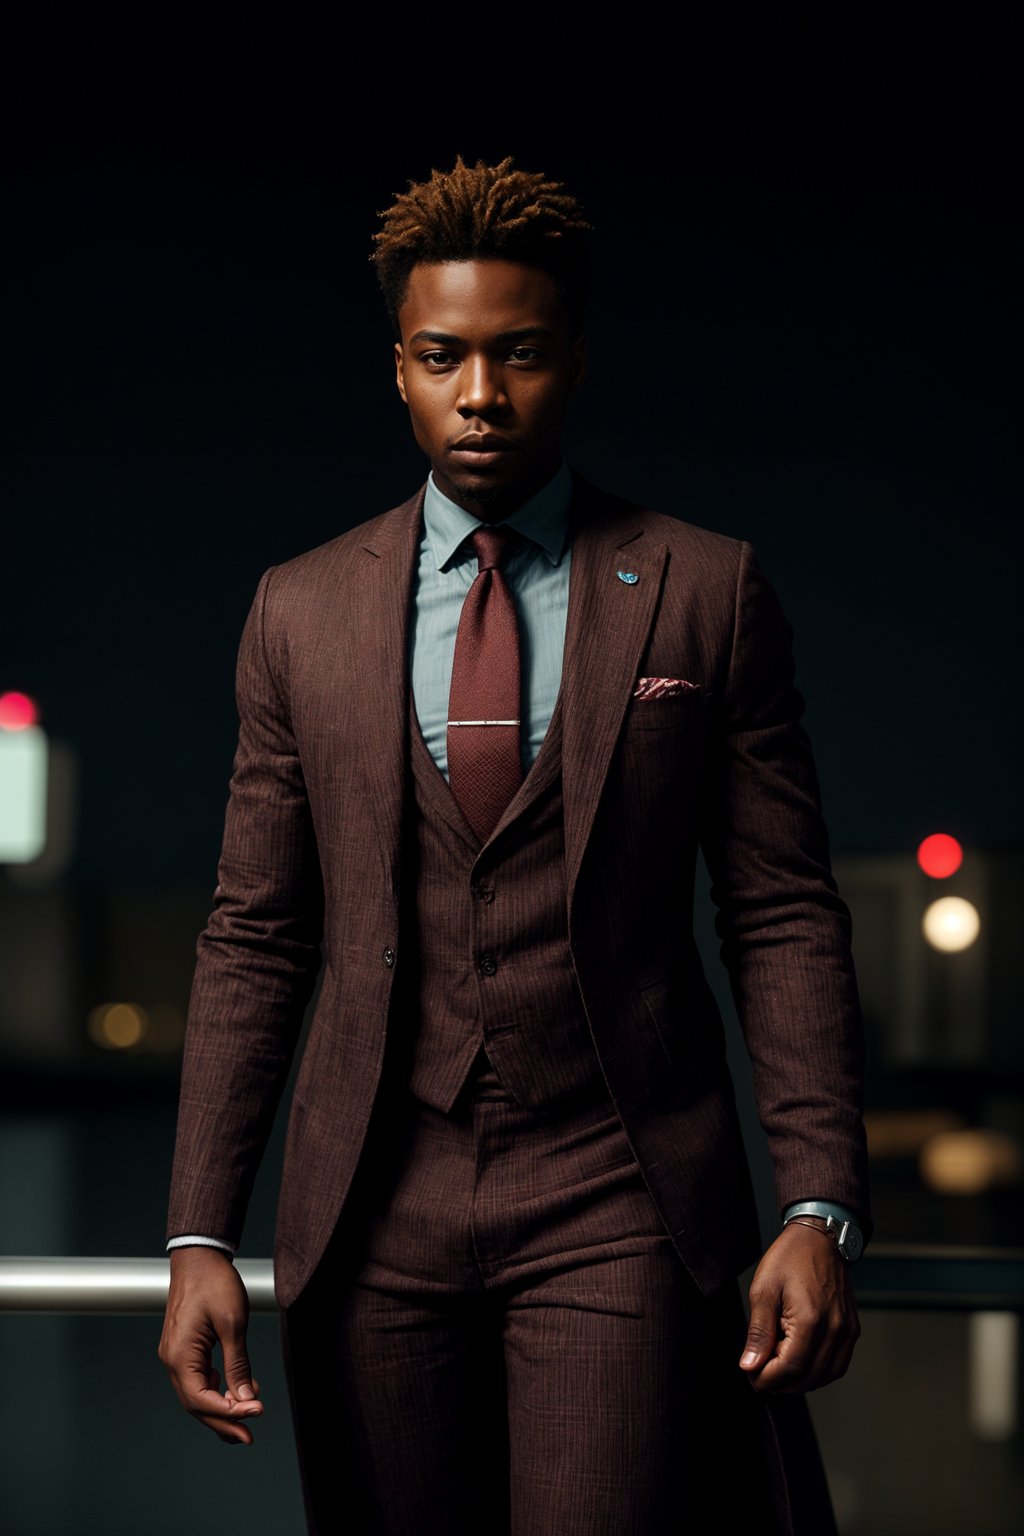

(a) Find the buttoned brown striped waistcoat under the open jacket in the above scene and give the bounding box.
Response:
[398,703,603,1115]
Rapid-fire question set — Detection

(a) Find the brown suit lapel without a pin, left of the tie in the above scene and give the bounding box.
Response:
[353,487,425,900]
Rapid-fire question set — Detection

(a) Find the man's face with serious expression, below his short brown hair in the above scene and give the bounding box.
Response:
[395,260,583,521]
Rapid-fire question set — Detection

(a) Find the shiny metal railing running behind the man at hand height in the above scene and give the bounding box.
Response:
[0,1243,1024,1313]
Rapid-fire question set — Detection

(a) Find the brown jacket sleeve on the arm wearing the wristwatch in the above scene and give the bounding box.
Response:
[702,544,870,1230]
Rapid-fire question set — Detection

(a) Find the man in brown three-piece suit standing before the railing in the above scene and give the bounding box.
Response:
[161,160,867,1536]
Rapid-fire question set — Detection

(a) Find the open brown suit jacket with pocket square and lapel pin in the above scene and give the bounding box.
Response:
[169,479,867,1306]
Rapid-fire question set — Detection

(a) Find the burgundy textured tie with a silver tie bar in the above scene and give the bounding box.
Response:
[448,528,522,843]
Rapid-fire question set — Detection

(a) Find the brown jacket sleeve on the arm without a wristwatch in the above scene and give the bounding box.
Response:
[167,570,324,1244]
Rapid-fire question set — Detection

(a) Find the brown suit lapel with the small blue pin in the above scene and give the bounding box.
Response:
[562,479,668,905]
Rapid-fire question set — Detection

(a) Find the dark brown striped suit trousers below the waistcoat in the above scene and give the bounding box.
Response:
[284,1058,810,1536]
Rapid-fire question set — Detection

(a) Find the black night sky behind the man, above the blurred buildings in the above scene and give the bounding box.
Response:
[0,6,1022,888]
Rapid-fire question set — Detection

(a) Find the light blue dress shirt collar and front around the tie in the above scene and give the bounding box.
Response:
[408,462,573,779]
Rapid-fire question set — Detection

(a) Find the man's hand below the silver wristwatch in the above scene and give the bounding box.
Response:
[740,1221,860,1392]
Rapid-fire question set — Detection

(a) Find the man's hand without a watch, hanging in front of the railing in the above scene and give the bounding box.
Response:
[158,1247,263,1445]
